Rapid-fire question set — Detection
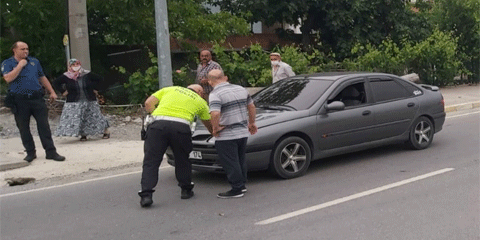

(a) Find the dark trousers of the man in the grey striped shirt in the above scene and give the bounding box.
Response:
[215,138,248,190]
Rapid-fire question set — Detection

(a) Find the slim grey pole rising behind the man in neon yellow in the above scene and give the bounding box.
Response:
[155,0,173,88]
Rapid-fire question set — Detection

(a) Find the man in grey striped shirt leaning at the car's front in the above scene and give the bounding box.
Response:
[208,69,257,198]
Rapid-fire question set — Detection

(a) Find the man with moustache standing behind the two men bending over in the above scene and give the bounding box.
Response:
[195,50,222,101]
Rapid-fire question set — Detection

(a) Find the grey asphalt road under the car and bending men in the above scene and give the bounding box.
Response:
[0,112,480,240]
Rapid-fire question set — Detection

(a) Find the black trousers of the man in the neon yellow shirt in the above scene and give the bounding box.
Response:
[141,120,193,192]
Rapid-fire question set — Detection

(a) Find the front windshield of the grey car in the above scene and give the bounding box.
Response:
[252,78,332,111]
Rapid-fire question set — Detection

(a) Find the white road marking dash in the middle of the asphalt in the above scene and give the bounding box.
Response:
[255,168,455,225]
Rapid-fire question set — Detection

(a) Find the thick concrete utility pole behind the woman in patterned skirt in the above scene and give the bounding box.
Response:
[68,0,92,69]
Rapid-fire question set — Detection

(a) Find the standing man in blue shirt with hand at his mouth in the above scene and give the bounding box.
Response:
[1,41,65,162]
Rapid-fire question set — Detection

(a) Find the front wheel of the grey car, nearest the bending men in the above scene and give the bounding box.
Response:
[269,137,312,179]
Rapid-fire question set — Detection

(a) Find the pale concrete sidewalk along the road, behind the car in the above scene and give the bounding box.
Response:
[0,85,480,185]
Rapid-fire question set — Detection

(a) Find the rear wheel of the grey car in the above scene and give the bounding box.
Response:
[408,117,435,150]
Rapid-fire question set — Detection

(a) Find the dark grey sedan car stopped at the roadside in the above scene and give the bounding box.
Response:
[166,73,445,178]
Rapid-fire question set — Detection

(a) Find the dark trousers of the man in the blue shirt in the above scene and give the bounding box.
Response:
[13,96,56,155]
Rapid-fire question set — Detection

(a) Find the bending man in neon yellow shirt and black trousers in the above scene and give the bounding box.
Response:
[138,84,212,207]
